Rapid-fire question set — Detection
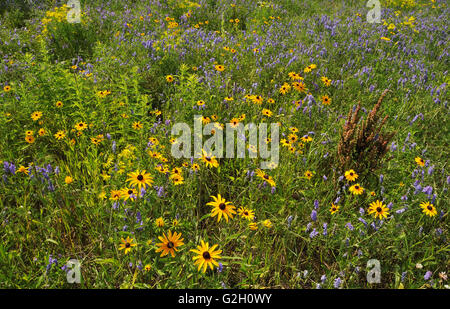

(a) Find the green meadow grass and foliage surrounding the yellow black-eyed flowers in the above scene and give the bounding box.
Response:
[0,1,449,288]
